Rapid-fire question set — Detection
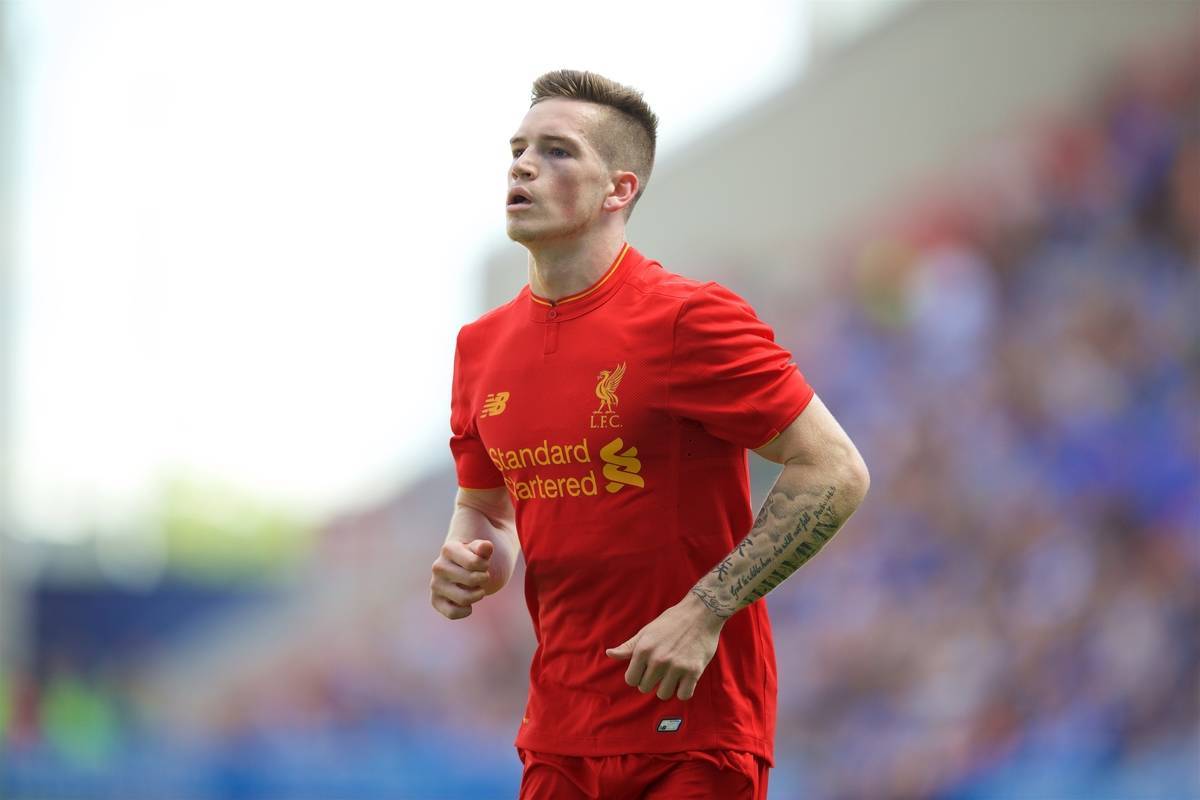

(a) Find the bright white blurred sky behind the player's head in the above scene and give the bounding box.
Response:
[6,0,857,540]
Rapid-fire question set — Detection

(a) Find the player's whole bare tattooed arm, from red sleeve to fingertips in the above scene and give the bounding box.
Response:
[607,397,870,700]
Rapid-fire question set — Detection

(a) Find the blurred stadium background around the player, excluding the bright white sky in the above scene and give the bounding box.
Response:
[0,0,1200,800]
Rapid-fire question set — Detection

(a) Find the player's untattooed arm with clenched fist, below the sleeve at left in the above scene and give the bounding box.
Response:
[430,486,521,619]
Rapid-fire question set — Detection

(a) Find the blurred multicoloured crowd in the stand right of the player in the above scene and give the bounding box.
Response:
[748,34,1200,798]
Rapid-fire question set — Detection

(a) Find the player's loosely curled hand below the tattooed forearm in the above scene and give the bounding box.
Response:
[605,593,725,700]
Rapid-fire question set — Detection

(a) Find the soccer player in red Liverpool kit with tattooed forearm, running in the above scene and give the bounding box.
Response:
[431,71,869,800]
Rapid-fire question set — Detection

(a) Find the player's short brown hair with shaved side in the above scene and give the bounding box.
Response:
[529,70,659,218]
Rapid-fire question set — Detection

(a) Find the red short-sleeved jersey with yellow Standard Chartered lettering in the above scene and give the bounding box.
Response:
[450,245,812,760]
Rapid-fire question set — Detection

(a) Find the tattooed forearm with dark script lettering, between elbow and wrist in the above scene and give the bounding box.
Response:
[691,485,845,619]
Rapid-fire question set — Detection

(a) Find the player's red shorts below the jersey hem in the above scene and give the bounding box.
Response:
[517,748,768,800]
